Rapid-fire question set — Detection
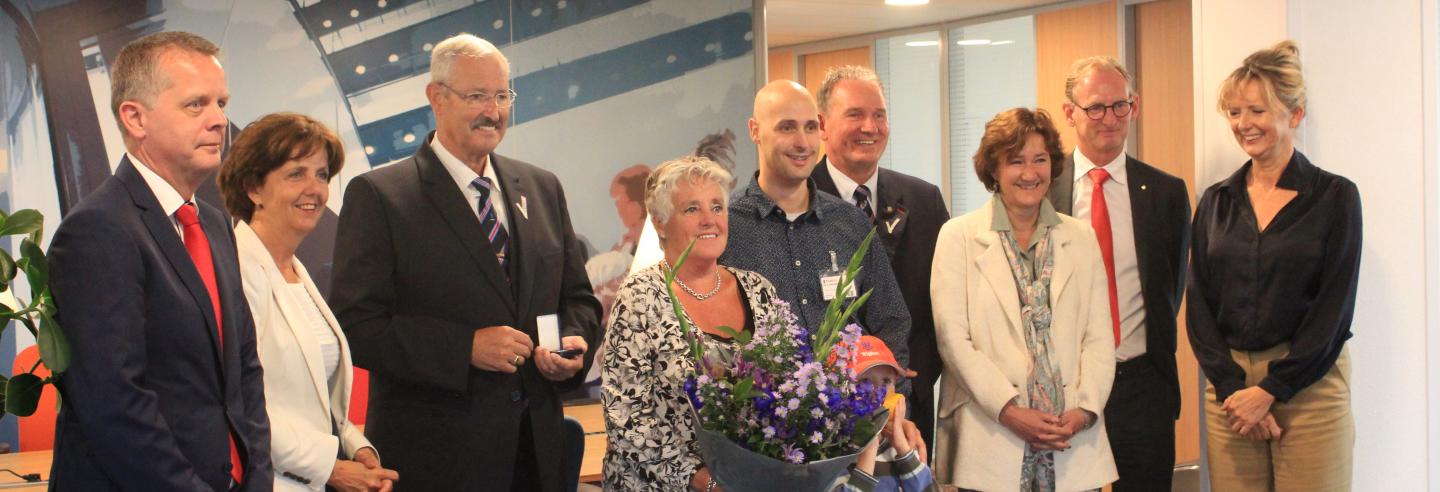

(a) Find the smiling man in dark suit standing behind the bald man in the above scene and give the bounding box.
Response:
[811,66,950,454]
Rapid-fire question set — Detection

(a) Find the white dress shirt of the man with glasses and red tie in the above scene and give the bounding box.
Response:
[1071,150,1145,363]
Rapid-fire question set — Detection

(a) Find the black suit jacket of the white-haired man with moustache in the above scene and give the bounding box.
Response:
[330,134,600,491]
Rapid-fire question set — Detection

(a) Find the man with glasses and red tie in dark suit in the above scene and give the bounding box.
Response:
[1050,56,1189,492]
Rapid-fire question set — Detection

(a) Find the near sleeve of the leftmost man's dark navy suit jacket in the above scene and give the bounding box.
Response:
[49,210,211,491]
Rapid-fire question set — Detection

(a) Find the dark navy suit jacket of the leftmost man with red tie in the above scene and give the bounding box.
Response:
[49,158,274,492]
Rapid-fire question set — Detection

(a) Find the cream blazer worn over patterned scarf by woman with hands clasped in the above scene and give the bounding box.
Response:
[930,199,1119,491]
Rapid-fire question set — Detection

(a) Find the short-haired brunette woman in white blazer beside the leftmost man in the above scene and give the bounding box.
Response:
[219,114,399,492]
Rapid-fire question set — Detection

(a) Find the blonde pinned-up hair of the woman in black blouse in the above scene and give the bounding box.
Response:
[1215,40,1305,114]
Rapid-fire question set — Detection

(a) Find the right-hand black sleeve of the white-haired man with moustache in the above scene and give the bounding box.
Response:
[554,181,602,390]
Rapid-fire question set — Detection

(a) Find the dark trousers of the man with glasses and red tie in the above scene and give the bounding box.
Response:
[1104,355,1178,492]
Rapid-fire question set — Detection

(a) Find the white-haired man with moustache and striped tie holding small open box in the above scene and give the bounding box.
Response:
[331,35,600,492]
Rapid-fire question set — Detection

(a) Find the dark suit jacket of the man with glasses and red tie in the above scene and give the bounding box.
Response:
[1050,154,1189,419]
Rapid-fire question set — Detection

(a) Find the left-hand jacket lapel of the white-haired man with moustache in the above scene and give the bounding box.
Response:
[415,141,516,315]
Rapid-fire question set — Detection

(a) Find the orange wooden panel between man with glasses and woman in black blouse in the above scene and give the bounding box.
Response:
[1133,0,1201,463]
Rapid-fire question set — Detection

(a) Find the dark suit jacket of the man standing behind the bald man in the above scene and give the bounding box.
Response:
[811,158,950,387]
